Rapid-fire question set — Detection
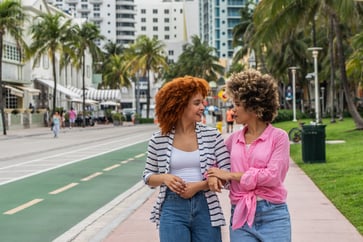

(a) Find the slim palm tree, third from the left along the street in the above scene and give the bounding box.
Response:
[72,22,105,127]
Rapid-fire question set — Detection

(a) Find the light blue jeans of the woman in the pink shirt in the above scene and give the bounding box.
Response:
[229,200,291,242]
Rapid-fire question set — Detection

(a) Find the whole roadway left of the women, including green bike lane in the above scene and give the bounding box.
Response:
[0,125,156,242]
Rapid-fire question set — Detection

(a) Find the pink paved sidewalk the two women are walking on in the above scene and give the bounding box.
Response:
[102,161,363,242]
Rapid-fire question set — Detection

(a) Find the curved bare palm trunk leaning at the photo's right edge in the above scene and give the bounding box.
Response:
[330,14,363,129]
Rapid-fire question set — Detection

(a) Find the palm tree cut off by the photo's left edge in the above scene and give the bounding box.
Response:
[0,0,26,135]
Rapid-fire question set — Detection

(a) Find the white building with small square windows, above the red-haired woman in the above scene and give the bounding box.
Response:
[135,0,199,62]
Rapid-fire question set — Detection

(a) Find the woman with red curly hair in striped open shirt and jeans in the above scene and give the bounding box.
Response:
[143,76,230,242]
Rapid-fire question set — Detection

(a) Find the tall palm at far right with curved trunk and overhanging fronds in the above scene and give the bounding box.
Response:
[254,0,363,129]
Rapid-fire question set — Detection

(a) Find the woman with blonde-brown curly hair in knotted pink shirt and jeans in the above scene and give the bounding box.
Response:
[208,70,291,242]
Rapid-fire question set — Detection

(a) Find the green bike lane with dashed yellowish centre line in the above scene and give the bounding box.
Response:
[0,142,147,242]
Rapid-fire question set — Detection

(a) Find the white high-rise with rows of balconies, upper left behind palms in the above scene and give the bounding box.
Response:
[47,0,136,48]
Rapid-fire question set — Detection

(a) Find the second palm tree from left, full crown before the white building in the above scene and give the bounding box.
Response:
[27,13,71,116]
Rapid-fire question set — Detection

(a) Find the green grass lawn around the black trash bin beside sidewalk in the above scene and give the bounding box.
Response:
[274,118,363,234]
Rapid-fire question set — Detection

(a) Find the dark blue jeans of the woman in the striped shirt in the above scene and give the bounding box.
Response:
[159,189,222,242]
